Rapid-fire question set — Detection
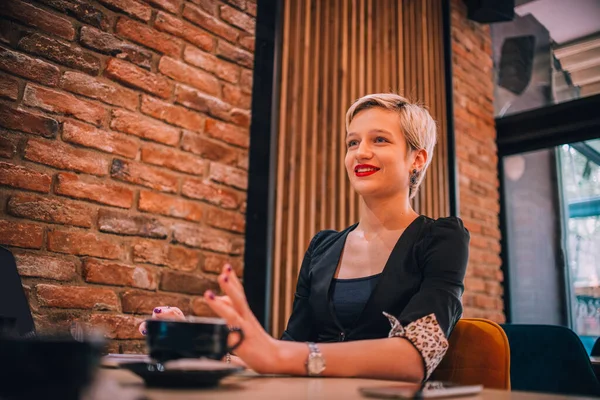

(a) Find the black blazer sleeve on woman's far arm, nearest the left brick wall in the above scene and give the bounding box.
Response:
[281,231,328,342]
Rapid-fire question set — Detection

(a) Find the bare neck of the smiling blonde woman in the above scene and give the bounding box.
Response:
[357,193,419,233]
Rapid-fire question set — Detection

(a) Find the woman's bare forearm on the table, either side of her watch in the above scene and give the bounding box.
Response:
[273,338,425,382]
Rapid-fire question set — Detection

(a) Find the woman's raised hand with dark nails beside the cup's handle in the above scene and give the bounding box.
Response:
[204,265,281,373]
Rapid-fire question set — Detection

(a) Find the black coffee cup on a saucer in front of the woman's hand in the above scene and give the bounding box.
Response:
[146,318,244,362]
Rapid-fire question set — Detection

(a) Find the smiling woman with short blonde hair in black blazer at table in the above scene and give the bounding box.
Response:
[140,94,469,381]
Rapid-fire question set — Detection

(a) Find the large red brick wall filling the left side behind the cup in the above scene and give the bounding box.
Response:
[0,0,256,351]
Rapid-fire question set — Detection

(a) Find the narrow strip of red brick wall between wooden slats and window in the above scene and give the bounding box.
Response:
[451,0,504,322]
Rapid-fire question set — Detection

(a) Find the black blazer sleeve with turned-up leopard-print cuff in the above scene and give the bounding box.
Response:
[384,217,470,379]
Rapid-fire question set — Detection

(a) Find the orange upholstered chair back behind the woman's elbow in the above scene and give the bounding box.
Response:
[431,318,510,390]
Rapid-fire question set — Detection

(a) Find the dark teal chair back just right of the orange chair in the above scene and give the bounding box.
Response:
[502,324,600,396]
